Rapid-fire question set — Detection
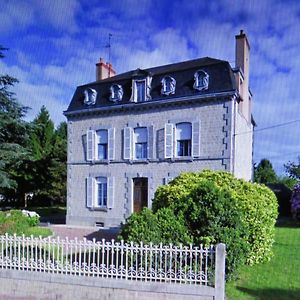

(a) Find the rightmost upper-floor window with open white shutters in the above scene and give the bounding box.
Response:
[164,121,200,158]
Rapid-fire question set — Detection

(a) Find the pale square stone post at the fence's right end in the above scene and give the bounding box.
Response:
[215,244,226,300]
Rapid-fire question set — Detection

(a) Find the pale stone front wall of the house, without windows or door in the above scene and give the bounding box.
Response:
[67,100,232,226]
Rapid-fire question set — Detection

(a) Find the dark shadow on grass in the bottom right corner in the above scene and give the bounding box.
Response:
[237,287,300,300]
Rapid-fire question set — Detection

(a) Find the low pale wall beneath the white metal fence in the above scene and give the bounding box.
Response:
[0,269,216,300]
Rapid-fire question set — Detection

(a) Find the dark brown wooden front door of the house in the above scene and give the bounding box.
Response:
[133,178,148,212]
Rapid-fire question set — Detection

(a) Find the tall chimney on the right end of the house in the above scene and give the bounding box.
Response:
[235,30,251,119]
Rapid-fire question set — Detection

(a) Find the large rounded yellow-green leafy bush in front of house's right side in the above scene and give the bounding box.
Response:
[153,170,278,264]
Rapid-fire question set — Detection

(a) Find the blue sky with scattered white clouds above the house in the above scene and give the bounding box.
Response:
[0,0,300,174]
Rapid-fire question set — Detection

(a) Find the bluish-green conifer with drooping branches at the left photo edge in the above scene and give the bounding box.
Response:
[0,46,29,194]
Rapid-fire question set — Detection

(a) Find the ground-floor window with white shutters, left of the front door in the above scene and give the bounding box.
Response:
[86,176,115,209]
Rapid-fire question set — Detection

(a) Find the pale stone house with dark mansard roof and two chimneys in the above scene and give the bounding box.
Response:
[64,31,255,227]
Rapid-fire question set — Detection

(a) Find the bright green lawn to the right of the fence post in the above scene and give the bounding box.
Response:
[226,222,300,300]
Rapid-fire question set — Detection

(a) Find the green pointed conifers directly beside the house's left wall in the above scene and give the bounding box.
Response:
[25,106,67,204]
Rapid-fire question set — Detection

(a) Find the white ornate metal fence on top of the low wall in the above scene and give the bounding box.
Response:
[0,234,225,286]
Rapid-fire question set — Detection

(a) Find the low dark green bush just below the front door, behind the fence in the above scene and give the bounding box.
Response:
[118,208,192,244]
